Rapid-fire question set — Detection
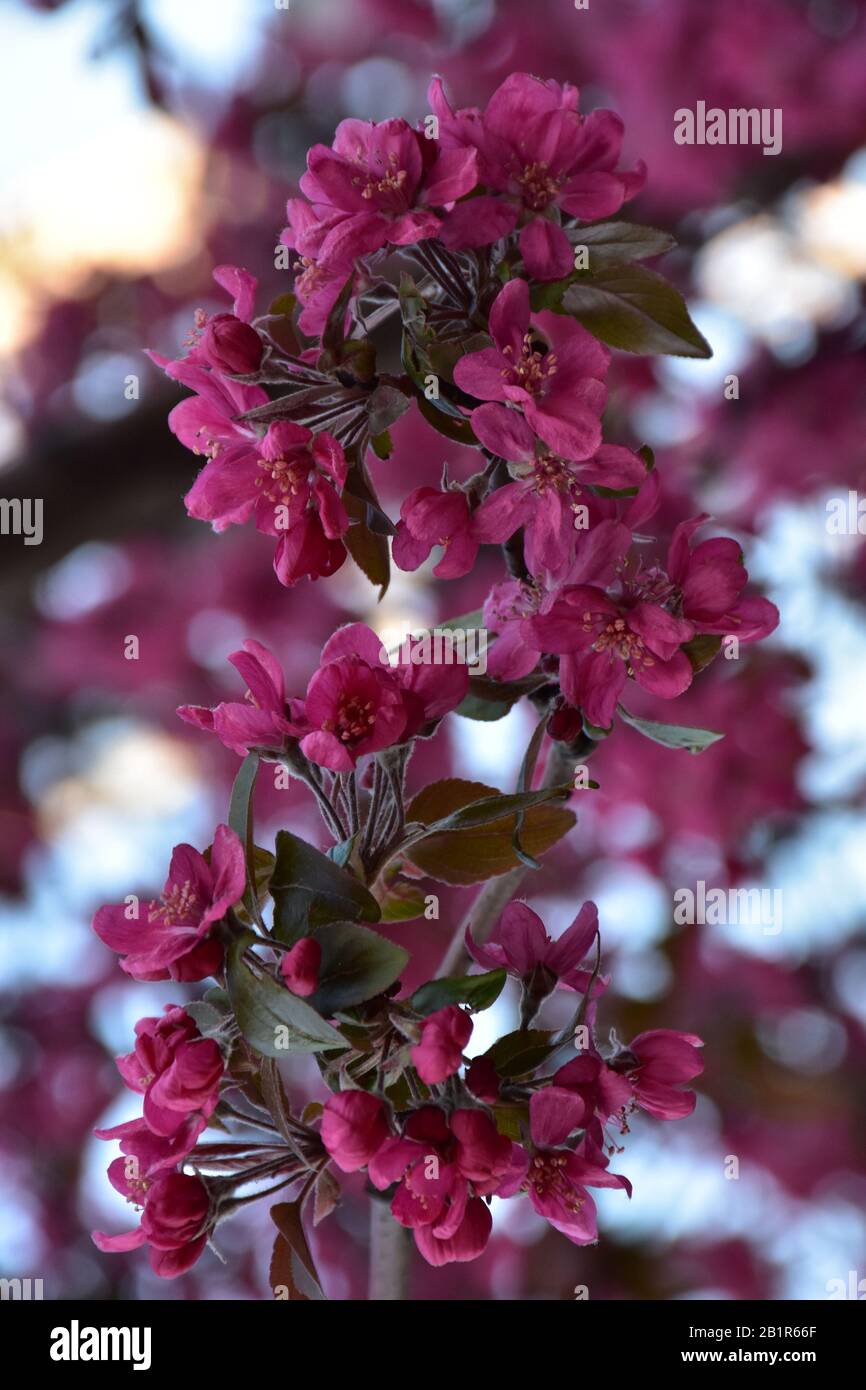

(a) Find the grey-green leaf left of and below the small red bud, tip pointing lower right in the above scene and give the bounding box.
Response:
[225,931,346,1058]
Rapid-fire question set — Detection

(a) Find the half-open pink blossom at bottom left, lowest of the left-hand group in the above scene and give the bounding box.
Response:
[93,1158,210,1279]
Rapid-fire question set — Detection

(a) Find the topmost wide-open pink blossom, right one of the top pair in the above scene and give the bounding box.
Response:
[428,72,646,279]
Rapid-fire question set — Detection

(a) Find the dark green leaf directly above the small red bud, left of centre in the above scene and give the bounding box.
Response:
[271,830,381,945]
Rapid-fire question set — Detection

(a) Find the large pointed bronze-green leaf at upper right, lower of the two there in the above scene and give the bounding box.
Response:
[562,264,713,357]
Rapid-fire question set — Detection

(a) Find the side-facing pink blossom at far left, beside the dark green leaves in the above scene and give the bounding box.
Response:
[93,826,246,980]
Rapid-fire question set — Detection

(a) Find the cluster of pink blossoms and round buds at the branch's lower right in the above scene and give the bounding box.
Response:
[321,904,702,1265]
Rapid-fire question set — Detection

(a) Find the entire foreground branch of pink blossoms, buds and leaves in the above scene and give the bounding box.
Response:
[95,74,777,1297]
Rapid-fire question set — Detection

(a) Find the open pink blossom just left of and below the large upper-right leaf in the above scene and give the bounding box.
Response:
[455,279,610,460]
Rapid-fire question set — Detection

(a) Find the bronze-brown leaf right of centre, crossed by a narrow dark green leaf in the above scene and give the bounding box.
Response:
[402,777,577,884]
